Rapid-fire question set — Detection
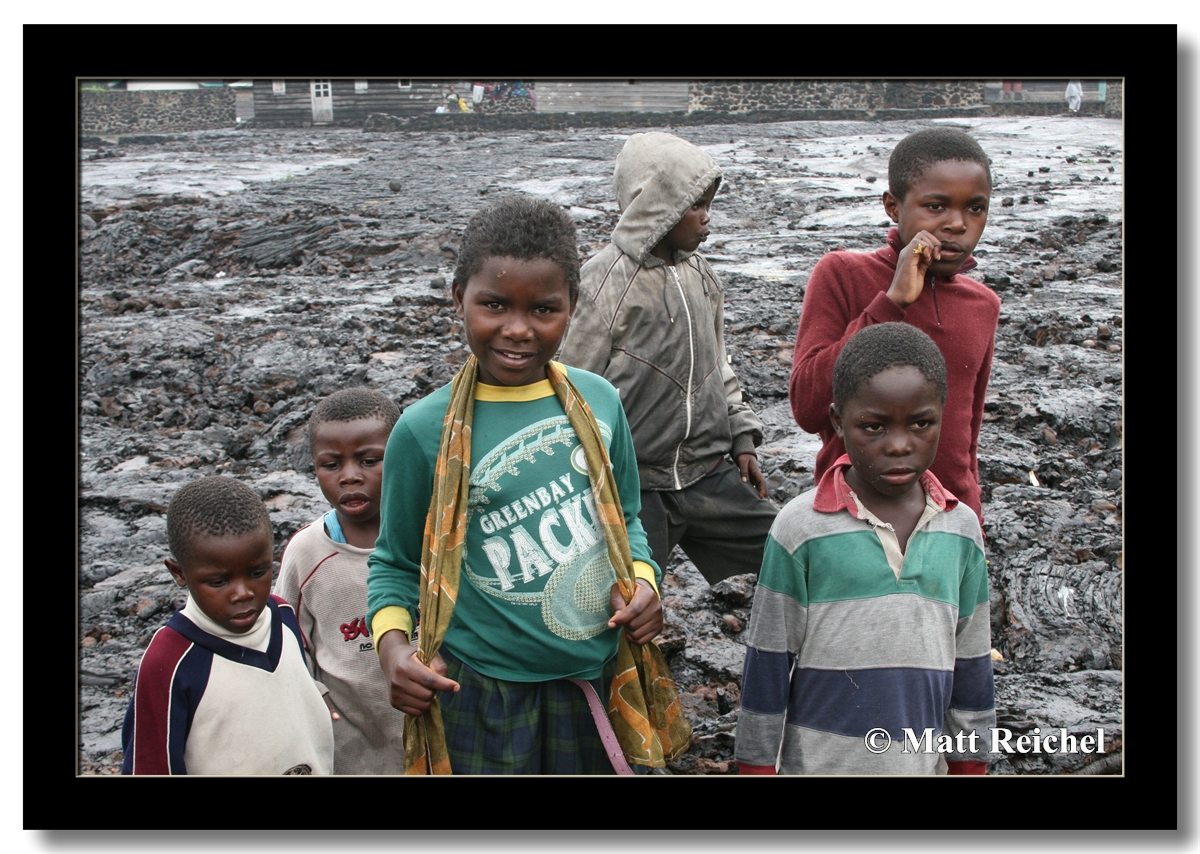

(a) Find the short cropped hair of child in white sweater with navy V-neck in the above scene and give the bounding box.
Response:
[167,475,271,563]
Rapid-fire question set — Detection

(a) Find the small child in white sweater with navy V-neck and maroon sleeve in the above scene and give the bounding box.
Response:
[121,476,334,775]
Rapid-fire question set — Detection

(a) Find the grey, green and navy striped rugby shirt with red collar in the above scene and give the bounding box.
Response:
[736,455,996,774]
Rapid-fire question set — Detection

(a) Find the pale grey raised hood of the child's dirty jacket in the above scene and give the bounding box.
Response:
[612,131,721,264]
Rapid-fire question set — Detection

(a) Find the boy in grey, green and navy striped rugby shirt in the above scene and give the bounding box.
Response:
[736,323,996,774]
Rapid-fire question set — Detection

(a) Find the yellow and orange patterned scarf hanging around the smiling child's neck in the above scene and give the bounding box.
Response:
[404,356,691,774]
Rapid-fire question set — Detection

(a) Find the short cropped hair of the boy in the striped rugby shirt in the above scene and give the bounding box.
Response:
[833,323,946,413]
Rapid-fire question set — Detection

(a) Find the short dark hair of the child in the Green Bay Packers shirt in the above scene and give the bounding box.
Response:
[454,196,580,302]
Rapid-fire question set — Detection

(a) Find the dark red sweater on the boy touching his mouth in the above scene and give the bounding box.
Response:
[788,228,1000,523]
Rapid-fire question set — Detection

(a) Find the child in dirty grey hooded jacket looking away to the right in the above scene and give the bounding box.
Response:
[559,132,779,584]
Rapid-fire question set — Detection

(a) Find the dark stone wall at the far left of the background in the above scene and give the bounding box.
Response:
[79,86,238,136]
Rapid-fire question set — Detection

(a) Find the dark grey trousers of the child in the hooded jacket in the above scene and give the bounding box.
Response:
[638,459,779,584]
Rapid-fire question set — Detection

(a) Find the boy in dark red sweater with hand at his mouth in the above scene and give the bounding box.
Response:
[788,127,1000,522]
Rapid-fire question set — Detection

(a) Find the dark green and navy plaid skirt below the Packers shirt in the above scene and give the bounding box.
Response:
[438,646,614,774]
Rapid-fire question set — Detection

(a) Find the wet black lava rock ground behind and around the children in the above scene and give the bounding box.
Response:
[78,116,1123,775]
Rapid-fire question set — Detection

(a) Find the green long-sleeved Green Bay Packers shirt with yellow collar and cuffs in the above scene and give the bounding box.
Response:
[367,368,661,681]
